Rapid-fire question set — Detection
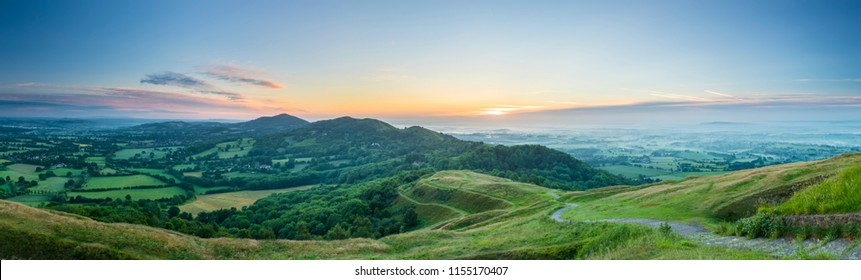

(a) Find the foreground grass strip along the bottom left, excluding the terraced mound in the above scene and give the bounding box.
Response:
[0,190,768,259]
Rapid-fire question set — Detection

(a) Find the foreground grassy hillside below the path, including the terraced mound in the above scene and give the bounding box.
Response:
[0,171,768,259]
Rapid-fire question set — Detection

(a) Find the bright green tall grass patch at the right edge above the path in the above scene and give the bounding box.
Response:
[773,166,861,215]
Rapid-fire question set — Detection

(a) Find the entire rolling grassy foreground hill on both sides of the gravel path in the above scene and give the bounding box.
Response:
[6,154,861,259]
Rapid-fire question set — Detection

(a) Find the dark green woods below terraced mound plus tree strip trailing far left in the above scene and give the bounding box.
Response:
[47,169,431,240]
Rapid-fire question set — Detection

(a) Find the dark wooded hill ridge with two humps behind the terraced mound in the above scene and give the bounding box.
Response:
[249,117,630,190]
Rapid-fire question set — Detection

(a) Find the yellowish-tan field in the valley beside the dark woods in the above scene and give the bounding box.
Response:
[179,186,314,215]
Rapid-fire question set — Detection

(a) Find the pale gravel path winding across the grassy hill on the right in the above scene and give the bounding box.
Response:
[550,203,861,260]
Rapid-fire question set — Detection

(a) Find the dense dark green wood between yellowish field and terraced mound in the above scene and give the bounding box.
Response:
[197,169,424,240]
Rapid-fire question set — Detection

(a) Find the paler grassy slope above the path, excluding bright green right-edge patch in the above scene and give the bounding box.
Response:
[563,154,861,225]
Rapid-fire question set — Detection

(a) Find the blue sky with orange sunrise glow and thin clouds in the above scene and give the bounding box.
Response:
[0,0,861,123]
